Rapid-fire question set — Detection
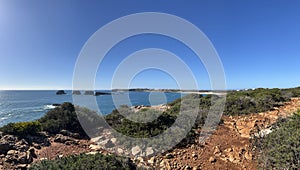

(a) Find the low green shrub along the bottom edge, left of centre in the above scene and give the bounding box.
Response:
[30,153,136,170]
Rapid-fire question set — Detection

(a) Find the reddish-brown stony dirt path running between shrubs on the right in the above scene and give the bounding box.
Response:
[156,98,300,170]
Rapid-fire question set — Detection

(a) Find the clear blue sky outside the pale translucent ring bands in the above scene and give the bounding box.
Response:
[0,0,300,89]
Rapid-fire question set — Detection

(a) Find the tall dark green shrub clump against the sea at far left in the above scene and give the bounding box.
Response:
[0,103,104,138]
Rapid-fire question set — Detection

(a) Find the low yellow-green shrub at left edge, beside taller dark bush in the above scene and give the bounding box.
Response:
[0,121,41,137]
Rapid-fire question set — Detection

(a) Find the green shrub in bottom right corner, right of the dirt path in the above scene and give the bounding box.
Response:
[254,111,300,169]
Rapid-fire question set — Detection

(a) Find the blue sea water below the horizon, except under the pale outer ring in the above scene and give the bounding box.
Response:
[0,90,182,127]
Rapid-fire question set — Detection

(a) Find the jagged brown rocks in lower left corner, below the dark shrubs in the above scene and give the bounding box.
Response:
[0,130,85,169]
